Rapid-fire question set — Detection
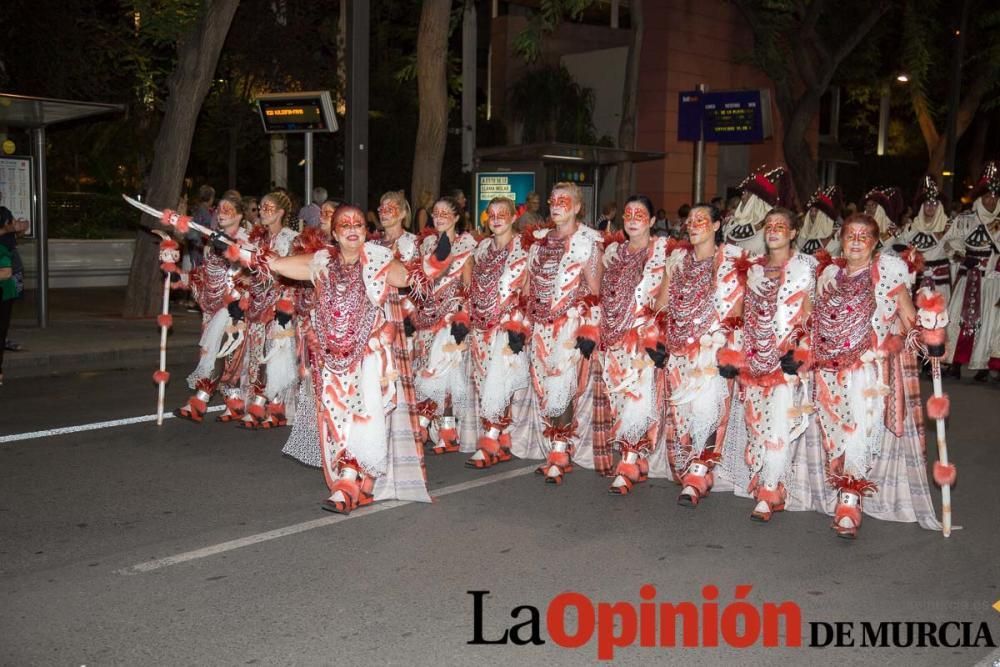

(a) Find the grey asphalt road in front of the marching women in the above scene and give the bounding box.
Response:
[0,366,1000,667]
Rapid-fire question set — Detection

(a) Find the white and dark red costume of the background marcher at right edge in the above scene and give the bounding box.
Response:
[944,204,1000,370]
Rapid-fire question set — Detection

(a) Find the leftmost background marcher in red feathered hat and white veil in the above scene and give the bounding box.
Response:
[722,166,795,255]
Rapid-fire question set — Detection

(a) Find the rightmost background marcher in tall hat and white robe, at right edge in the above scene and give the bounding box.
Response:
[945,161,1000,382]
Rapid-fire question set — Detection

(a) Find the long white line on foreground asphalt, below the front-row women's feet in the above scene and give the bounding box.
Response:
[115,465,535,575]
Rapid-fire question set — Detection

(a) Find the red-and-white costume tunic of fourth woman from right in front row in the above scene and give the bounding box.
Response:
[601,237,668,452]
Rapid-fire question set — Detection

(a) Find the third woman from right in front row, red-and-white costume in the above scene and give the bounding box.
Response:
[656,204,748,507]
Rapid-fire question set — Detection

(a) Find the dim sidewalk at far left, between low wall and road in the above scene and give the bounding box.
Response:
[3,287,201,379]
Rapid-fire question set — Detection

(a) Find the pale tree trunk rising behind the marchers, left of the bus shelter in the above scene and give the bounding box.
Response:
[410,0,451,206]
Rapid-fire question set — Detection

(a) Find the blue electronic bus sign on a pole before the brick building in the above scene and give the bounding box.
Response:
[677,88,773,144]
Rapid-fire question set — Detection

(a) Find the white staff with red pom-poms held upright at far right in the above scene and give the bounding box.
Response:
[916,287,961,537]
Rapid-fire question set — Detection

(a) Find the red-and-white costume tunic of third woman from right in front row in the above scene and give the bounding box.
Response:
[666,244,746,478]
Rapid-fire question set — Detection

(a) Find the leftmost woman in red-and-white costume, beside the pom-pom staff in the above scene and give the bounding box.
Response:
[174,196,249,423]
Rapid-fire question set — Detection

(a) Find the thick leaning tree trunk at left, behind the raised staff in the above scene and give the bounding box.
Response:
[122,0,240,317]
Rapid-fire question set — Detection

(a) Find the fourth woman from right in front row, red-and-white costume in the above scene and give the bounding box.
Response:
[594,195,672,495]
